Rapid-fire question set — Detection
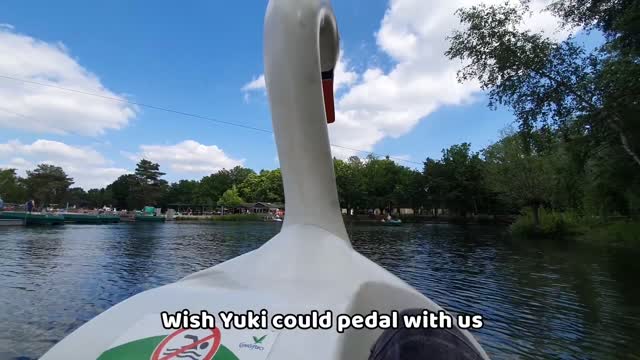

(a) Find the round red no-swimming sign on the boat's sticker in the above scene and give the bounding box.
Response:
[151,328,221,360]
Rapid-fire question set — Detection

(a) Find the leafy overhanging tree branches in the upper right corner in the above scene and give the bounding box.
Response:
[446,0,640,166]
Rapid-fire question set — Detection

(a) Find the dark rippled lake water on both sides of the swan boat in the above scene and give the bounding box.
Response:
[0,223,640,359]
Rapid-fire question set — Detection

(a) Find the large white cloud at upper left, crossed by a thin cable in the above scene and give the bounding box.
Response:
[0,24,137,135]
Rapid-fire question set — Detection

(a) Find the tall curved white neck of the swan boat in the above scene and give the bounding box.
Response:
[264,0,349,242]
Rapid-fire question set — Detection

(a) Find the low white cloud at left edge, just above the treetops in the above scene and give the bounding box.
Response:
[0,139,128,190]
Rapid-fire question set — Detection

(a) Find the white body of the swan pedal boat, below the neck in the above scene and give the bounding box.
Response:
[41,225,488,360]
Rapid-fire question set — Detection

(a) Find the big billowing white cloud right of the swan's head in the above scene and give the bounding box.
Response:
[244,0,567,157]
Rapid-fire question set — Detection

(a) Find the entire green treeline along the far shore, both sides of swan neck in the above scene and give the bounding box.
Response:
[0,127,640,222]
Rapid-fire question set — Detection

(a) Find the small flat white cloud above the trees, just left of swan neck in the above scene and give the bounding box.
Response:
[129,140,244,175]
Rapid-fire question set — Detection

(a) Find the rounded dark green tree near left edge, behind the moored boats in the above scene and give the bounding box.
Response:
[25,164,73,206]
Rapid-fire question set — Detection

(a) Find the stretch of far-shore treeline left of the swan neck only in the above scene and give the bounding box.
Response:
[0,159,284,210]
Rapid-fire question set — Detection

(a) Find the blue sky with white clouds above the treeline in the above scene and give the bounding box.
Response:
[0,0,592,189]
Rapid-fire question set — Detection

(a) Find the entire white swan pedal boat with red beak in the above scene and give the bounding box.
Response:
[42,0,488,360]
